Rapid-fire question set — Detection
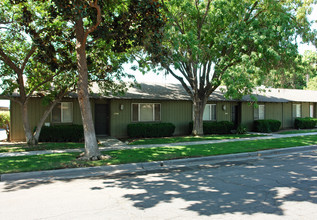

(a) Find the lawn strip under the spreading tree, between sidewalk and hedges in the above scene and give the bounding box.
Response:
[129,134,264,145]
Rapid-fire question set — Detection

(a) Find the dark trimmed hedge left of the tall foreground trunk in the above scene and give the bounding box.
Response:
[39,125,84,142]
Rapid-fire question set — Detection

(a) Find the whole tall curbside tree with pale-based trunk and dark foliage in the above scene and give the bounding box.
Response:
[51,0,163,160]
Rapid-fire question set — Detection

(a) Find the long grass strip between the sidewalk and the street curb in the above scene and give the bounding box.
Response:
[0,135,317,174]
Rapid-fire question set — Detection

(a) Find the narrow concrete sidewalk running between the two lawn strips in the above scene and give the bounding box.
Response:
[0,132,317,158]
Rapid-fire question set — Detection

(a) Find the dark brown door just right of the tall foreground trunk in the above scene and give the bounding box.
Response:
[95,104,110,135]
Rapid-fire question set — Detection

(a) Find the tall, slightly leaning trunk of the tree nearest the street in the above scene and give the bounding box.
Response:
[75,18,101,160]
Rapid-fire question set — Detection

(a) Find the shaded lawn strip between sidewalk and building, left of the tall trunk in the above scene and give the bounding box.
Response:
[0,143,84,153]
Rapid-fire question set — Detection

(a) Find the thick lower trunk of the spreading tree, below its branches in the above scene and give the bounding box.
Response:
[192,97,207,136]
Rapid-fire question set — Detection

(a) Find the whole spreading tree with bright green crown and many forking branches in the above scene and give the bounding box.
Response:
[141,0,316,135]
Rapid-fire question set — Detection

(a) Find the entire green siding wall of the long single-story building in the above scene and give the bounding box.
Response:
[10,98,317,141]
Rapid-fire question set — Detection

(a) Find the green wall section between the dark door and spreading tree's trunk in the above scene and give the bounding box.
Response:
[110,100,192,137]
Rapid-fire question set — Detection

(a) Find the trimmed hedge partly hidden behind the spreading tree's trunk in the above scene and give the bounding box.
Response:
[189,121,234,134]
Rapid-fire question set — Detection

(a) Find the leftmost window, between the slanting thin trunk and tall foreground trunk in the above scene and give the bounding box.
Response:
[52,102,73,123]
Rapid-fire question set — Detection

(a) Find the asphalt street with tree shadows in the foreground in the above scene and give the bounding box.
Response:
[0,150,317,220]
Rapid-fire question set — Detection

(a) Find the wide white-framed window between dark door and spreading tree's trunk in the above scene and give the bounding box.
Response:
[132,103,161,121]
